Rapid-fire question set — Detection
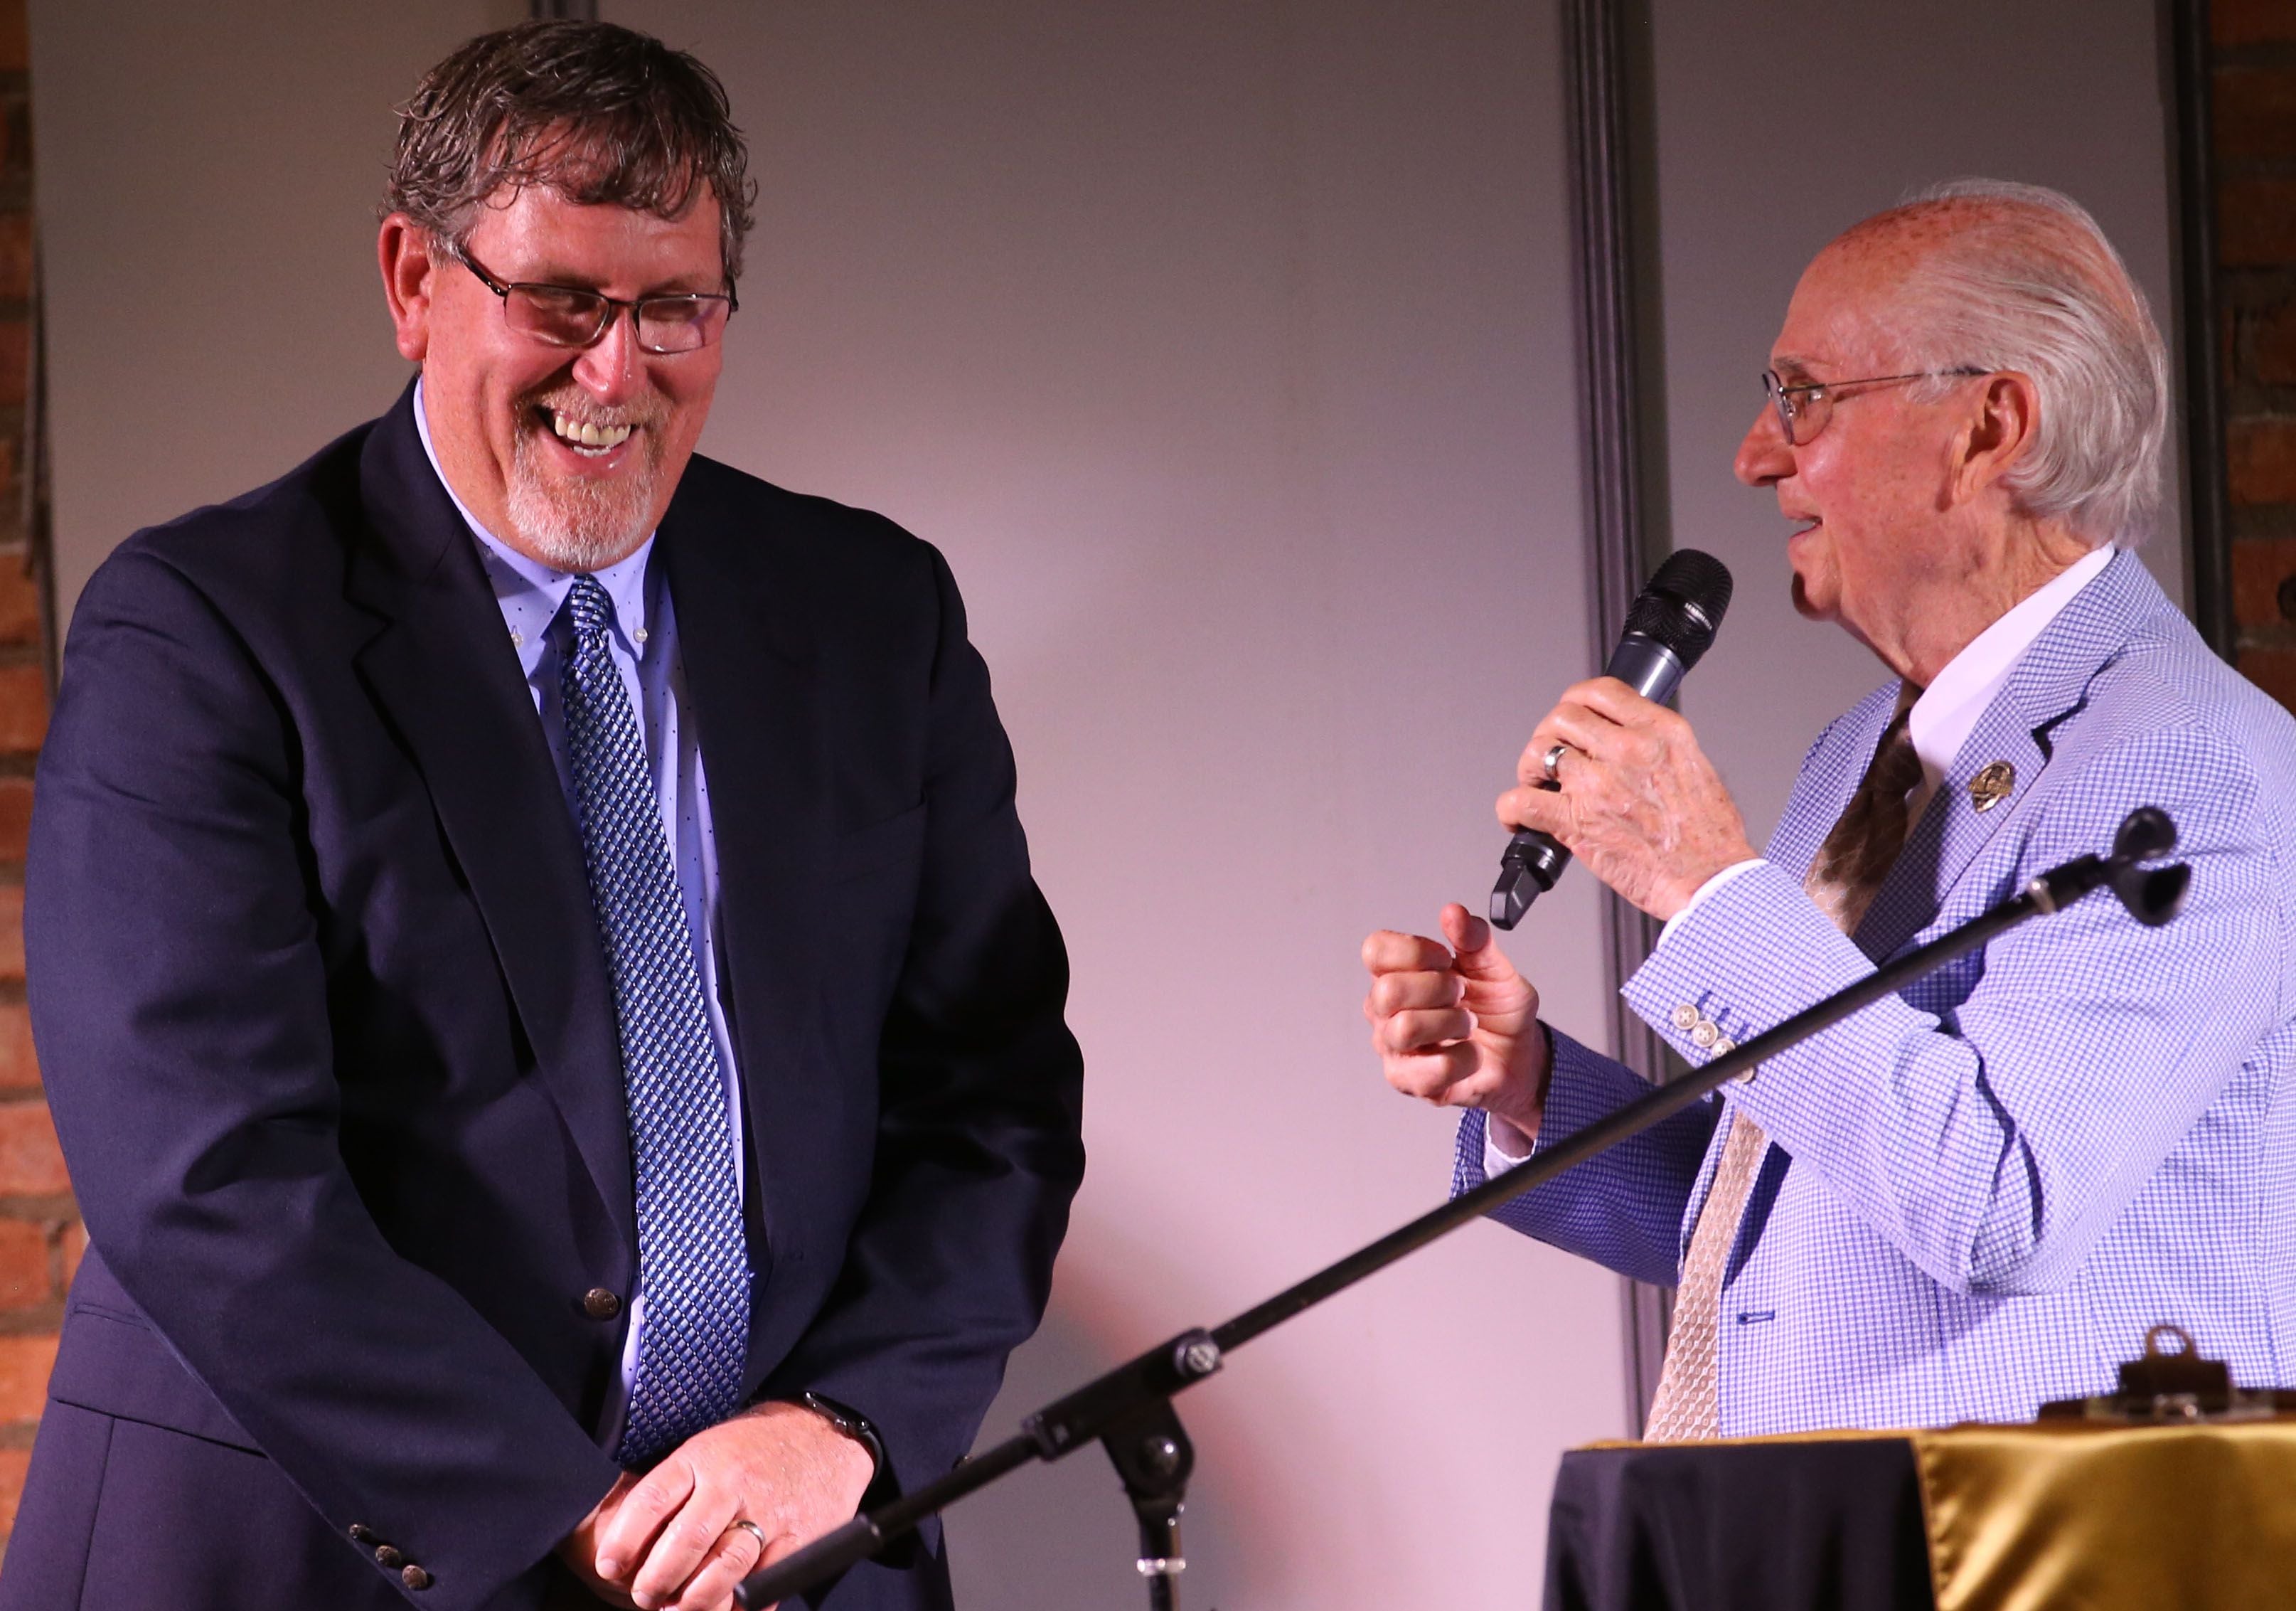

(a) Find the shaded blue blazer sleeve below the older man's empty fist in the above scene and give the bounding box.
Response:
[1451,1030,1715,1287]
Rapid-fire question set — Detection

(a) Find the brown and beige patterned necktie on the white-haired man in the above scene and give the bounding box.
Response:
[1644,685,1922,1443]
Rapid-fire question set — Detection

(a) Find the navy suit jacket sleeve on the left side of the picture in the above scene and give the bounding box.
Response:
[26,543,615,1611]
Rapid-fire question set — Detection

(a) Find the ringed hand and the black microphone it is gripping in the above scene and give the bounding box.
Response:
[1490,549,1754,928]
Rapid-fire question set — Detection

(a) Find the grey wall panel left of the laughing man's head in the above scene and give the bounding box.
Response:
[30,0,523,618]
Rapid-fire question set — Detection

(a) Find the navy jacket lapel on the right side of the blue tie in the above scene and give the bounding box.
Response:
[656,478,826,1257]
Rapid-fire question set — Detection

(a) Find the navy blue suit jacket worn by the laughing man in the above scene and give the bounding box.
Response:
[0,395,1084,1611]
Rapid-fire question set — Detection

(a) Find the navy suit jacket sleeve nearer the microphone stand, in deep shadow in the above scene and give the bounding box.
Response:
[760,551,1084,1489]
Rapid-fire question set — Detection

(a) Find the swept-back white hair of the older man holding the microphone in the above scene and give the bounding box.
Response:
[1851,179,2169,547]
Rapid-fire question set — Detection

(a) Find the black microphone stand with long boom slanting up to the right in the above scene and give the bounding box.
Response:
[735,807,2193,1611]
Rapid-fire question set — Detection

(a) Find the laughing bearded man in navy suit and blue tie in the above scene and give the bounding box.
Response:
[0,23,1084,1611]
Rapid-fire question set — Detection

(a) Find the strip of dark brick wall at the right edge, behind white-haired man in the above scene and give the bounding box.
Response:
[2209,0,2296,693]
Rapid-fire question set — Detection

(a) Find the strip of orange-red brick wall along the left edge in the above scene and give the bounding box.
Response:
[0,0,58,1547]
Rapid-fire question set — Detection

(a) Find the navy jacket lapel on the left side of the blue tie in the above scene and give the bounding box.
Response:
[349,386,636,1257]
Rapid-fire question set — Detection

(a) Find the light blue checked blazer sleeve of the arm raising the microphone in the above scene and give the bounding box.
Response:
[1628,722,2289,1294]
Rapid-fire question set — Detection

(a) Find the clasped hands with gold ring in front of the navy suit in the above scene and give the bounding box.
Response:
[558,1404,875,1611]
